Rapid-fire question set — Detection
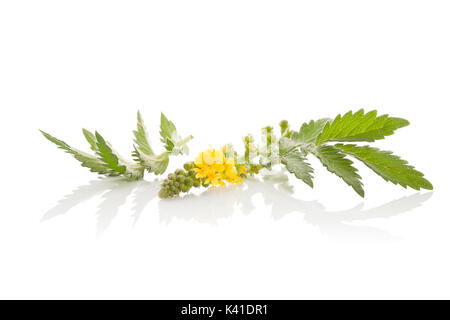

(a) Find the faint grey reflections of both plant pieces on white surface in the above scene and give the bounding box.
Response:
[42,174,432,240]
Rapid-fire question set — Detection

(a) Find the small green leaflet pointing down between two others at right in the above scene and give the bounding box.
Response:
[313,146,364,197]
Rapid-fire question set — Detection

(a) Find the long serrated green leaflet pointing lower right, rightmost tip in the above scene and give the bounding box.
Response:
[335,144,433,190]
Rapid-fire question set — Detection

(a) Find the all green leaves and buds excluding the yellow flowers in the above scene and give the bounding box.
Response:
[41,110,433,198]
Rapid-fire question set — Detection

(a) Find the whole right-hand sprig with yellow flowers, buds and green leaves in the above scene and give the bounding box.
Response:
[160,110,433,198]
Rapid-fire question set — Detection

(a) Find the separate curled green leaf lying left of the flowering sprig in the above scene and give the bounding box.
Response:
[41,112,192,179]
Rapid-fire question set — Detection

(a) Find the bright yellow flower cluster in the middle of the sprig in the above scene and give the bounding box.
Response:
[194,147,243,186]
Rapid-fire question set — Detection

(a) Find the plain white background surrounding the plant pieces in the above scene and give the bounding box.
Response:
[0,0,450,299]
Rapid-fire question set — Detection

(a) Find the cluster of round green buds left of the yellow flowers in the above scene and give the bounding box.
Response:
[158,162,201,199]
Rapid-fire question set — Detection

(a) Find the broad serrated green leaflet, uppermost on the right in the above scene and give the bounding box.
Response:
[316,109,409,145]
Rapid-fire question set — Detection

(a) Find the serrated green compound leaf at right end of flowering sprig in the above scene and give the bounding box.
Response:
[279,110,433,197]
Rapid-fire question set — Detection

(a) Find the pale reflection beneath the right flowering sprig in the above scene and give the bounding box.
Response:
[158,170,432,241]
